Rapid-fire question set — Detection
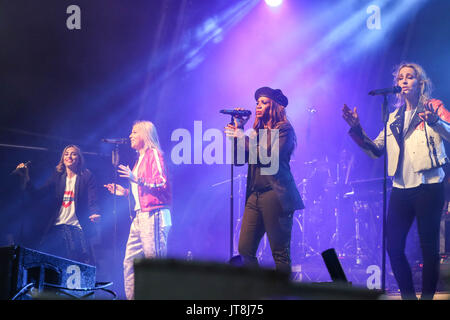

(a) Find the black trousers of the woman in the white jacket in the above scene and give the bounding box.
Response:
[386,183,445,299]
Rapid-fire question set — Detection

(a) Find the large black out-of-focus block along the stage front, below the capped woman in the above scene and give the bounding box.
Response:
[134,259,380,300]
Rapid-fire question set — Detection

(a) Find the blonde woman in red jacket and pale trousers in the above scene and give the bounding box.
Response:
[105,121,172,300]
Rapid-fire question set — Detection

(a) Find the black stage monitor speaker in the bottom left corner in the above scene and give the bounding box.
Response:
[0,246,96,300]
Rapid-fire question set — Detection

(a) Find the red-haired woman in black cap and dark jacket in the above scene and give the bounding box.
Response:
[225,87,304,273]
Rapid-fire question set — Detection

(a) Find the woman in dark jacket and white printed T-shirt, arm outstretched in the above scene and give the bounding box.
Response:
[17,145,100,264]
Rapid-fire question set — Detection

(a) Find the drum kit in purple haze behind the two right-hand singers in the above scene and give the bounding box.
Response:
[248,151,390,274]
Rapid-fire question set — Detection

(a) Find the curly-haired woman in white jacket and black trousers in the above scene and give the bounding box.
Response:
[343,63,450,299]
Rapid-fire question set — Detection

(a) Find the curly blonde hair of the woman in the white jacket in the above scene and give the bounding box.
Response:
[392,62,433,108]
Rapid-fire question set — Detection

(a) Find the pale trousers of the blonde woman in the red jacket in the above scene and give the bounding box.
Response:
[123,209,172,300]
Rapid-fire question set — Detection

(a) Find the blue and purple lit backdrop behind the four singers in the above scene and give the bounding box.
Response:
[0,0,450,300]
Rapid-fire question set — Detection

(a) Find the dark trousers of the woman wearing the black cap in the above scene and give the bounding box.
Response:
[238,190,293,273]
